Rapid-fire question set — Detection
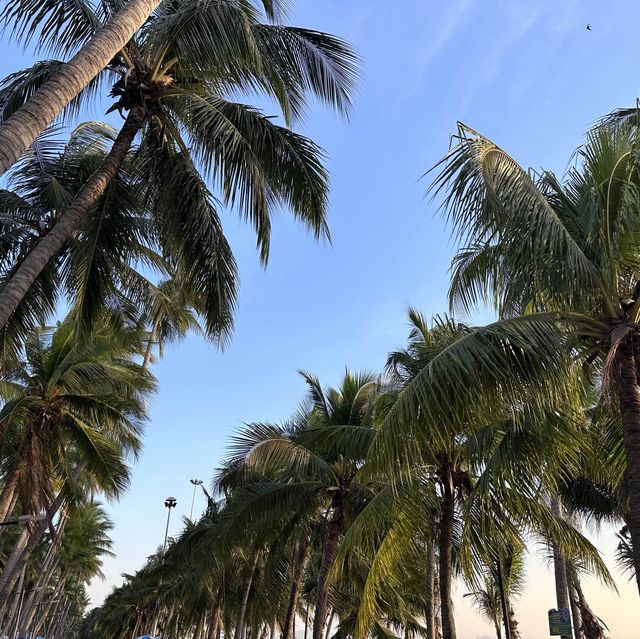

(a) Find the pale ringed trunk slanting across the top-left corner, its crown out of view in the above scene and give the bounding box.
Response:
[0,0,160,178]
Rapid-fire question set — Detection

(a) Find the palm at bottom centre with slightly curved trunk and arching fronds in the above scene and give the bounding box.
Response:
[222,371,377,639]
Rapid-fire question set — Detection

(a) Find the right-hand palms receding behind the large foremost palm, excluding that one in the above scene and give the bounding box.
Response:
[75,311,625,639]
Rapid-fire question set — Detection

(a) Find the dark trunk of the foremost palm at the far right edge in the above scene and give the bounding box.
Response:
[617,337,640,591]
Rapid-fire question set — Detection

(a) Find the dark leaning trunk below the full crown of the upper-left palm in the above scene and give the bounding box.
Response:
[0,104,148,328]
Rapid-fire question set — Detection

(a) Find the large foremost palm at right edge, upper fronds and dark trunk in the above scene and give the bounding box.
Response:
[424,119,640,588]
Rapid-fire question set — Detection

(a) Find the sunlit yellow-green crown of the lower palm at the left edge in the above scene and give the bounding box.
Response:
[0,321,154,513]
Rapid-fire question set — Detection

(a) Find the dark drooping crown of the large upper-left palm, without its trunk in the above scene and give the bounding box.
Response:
[0,0,357,350]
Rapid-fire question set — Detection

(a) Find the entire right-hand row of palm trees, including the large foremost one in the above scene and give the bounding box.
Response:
[83,112,640,639]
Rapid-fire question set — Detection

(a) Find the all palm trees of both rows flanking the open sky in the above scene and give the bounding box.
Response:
[0,0,640,639]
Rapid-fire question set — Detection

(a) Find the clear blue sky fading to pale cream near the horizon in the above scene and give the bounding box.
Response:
[5,0,640,639]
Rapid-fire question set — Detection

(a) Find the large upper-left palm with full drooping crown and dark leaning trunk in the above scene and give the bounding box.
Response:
[0,0,355,338]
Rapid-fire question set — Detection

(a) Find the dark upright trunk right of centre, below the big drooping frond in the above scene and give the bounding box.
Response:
[439,467,456,639]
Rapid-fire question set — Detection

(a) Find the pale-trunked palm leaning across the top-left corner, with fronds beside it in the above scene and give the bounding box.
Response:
[0,0,288,175]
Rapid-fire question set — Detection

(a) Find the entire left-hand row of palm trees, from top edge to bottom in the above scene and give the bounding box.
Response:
[0,0,358,639]
